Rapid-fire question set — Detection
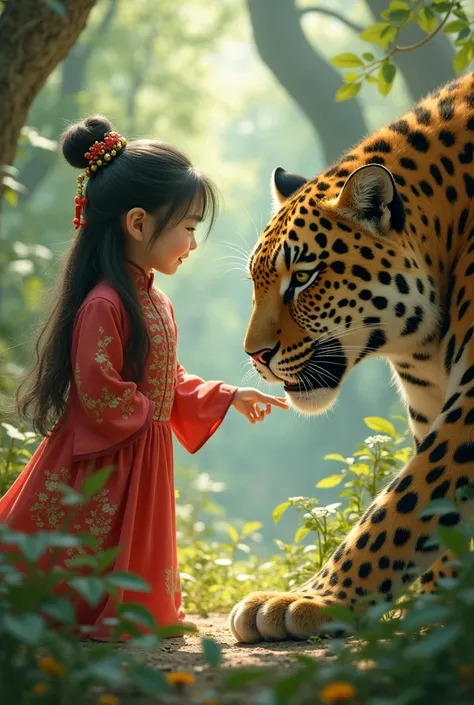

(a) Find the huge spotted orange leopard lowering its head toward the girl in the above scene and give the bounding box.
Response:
[229,71,474,643]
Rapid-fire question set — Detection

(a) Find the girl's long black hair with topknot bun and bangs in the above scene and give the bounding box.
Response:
[16,116,217,436]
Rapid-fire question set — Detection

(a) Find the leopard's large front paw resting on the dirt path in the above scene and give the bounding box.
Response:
[229,592,328,644]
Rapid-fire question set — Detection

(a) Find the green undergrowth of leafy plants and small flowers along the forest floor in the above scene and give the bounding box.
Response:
[0,417,474,705]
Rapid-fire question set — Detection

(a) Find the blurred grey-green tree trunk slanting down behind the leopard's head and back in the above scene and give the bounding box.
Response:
[247,0,367,164]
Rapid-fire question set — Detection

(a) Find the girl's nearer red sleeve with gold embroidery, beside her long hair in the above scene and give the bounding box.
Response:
[72,298,154,460]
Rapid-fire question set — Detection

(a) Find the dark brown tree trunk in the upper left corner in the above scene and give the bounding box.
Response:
[0,0,96,204]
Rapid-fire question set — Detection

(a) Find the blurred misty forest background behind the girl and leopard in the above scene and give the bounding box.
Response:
[0,0,474,548]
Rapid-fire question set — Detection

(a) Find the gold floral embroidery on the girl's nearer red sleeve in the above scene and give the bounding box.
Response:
[74,326,135,423]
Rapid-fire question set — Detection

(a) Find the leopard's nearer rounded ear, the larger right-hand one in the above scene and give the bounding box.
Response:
[334,164,406,233]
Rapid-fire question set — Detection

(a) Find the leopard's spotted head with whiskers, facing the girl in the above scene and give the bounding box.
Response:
[244,164,437,414]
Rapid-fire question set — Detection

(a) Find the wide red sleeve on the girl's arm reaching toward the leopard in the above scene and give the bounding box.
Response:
[171,362,237,453]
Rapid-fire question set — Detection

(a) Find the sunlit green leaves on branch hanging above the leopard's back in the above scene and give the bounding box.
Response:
[331,0,474,101]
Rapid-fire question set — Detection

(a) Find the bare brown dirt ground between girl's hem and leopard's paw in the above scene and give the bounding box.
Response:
[97,614,329,705]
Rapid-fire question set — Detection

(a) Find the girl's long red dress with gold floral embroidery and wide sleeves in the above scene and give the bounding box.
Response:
[0,265,236,639]
